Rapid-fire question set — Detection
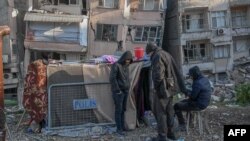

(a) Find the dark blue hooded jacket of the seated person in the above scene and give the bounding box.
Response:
[189,66,212,109]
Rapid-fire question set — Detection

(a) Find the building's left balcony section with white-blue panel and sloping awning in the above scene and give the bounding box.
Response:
[24,0,88,70]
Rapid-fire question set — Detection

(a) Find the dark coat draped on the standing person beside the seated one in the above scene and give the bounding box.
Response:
[151,47,187,98]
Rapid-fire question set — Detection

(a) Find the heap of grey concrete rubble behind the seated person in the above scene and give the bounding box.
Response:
[185,57,250,103]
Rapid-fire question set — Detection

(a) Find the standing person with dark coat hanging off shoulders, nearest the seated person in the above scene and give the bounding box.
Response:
[146,42,186,141]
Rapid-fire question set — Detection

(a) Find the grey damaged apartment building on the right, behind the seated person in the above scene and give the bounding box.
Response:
[164,0,250,80]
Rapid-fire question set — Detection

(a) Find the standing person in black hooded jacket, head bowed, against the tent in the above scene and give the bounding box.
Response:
[109,51,133,135]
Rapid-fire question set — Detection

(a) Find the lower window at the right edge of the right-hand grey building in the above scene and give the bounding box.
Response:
[234,39,250,52]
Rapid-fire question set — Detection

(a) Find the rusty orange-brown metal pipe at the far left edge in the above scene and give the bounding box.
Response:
[0,26,10,141]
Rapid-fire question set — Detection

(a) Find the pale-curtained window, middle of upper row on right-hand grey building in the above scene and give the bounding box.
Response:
[212,11,226,28]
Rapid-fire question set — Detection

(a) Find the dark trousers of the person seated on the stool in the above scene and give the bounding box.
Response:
[174,99,202,125]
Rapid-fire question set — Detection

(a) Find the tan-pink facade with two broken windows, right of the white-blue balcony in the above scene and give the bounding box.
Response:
[88,0,166,56]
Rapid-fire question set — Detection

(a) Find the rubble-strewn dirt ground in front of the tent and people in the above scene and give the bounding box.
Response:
[3,105,250,141]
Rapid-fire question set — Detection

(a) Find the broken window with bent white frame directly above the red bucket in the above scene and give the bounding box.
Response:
[134,26,162,44]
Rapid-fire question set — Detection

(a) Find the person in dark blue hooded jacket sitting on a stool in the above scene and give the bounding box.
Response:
[174,66,212,131]
